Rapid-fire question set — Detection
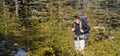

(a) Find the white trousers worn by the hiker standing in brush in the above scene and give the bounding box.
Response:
[74,35,85,51]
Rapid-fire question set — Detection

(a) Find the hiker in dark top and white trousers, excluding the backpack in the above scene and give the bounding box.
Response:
[72,16,90,51]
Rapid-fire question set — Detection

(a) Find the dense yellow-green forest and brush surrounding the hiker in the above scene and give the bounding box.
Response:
[0,0,120,56]
